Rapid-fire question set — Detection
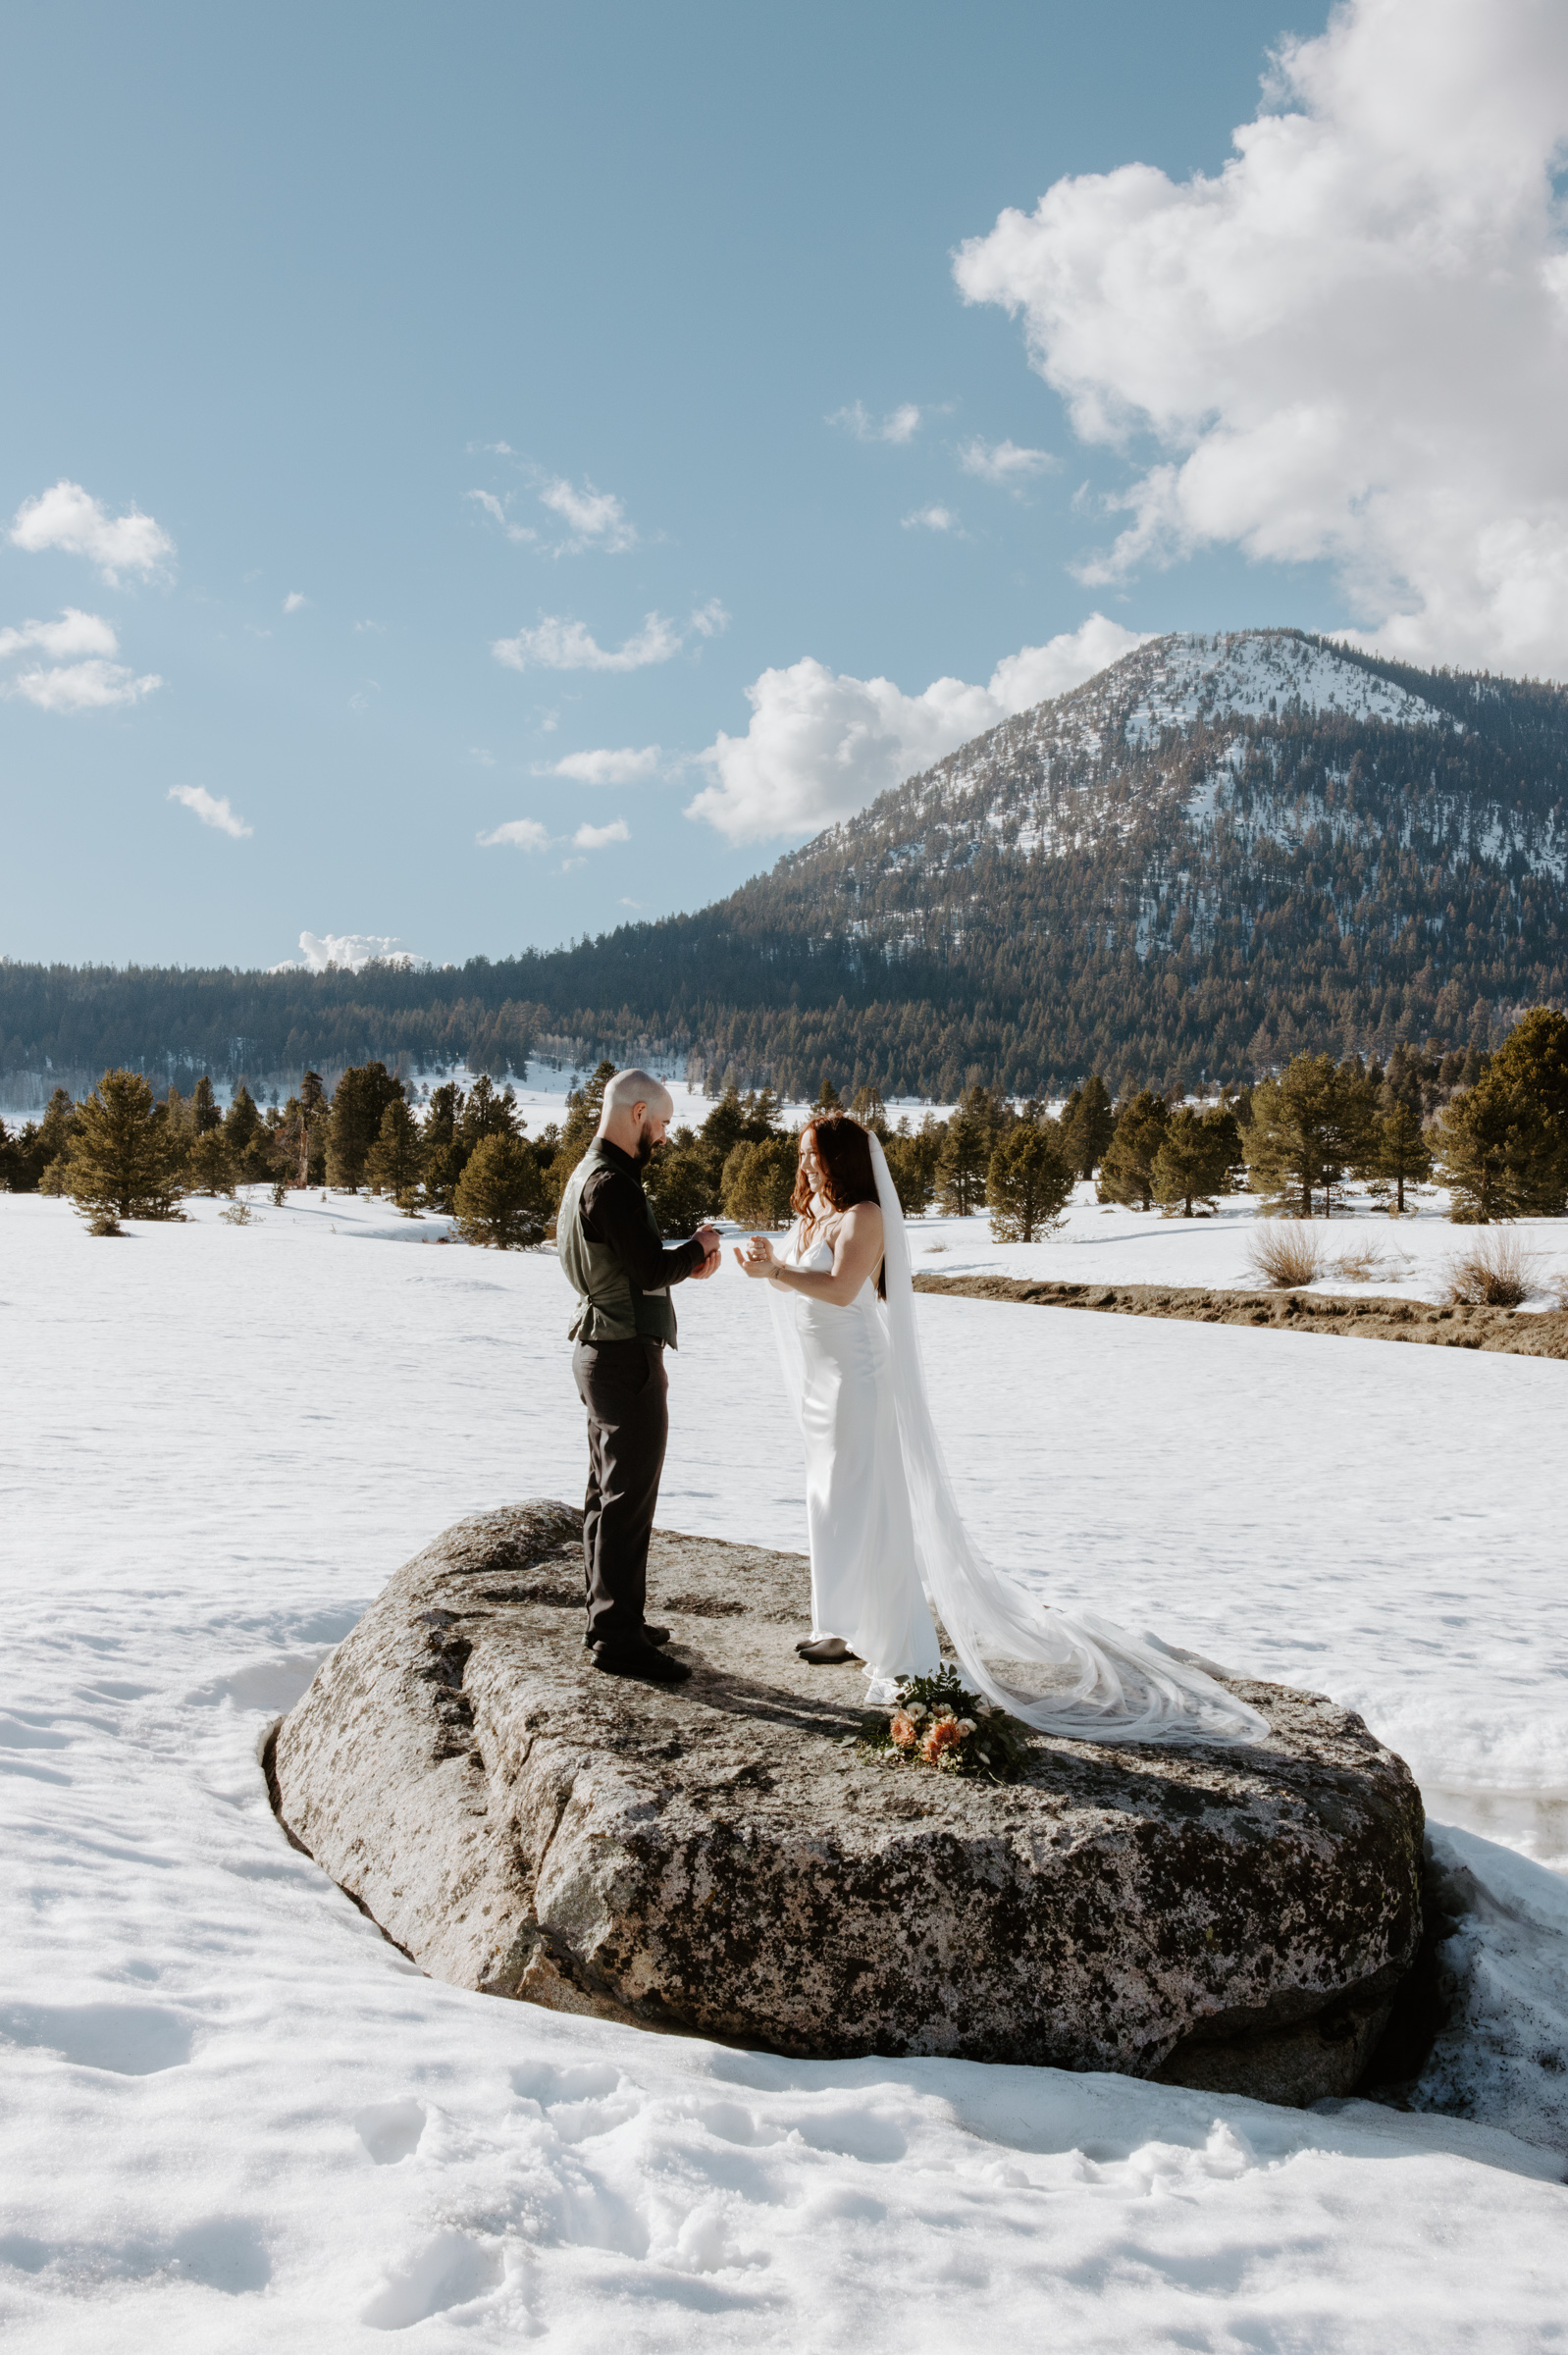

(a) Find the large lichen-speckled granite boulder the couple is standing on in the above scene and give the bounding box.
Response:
[269,1502,1422,2103]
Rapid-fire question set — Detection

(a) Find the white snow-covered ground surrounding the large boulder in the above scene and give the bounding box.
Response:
[0,1186,1568,2355]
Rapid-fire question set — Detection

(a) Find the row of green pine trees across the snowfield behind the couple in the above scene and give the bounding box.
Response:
[0,1006,1568,1248]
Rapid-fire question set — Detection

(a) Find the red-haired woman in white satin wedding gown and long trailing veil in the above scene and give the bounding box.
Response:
[735,1112,1269,1743]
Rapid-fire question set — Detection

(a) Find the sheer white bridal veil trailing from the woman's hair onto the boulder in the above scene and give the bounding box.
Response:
[770,1137,1269,1743]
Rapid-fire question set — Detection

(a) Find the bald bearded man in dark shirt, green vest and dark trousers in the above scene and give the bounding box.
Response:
[555,1072,718,1684]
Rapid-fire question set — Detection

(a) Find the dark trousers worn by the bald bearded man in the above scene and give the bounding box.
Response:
[572,1340,668,1648]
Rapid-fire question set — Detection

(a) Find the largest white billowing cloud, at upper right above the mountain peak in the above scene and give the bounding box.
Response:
[956,0,1568,678]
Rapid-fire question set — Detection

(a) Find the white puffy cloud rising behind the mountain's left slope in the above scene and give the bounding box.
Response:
[685,612,1144,843]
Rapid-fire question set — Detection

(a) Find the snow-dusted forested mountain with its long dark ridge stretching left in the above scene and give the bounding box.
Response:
[0,629,1568,1097]
